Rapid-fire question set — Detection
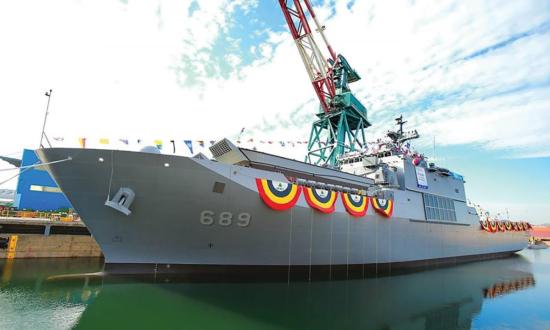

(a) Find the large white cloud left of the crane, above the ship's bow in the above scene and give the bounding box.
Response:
[0,0,266,181]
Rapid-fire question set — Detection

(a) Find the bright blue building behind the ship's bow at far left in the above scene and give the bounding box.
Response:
[14,149,72,211]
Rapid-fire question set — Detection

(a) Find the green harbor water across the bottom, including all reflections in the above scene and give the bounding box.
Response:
[0,249,550,329]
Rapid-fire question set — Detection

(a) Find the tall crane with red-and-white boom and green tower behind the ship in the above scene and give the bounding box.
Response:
[279,0,370,166]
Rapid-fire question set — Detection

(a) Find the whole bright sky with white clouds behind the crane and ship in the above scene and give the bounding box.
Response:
[0,0,550,222]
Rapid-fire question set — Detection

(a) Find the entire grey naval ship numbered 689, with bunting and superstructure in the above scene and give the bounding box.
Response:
[36,118,528,279]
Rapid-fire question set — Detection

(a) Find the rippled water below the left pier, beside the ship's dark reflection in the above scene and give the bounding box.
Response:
[0,258,103,329]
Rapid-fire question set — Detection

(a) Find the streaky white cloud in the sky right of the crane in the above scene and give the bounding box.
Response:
[306,1,550,157]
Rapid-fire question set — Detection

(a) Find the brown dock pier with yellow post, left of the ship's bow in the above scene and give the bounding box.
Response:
[0,217,102,259]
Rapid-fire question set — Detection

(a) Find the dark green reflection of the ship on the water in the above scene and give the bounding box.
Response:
[72,257,535,329]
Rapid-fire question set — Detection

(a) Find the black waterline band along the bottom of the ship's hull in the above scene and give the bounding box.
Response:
[104,251,517,282]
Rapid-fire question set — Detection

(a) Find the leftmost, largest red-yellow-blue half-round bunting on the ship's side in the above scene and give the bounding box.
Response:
[256,179,302,211]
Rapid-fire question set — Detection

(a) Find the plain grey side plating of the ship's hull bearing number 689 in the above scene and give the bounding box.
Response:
[37,148,527,276]
